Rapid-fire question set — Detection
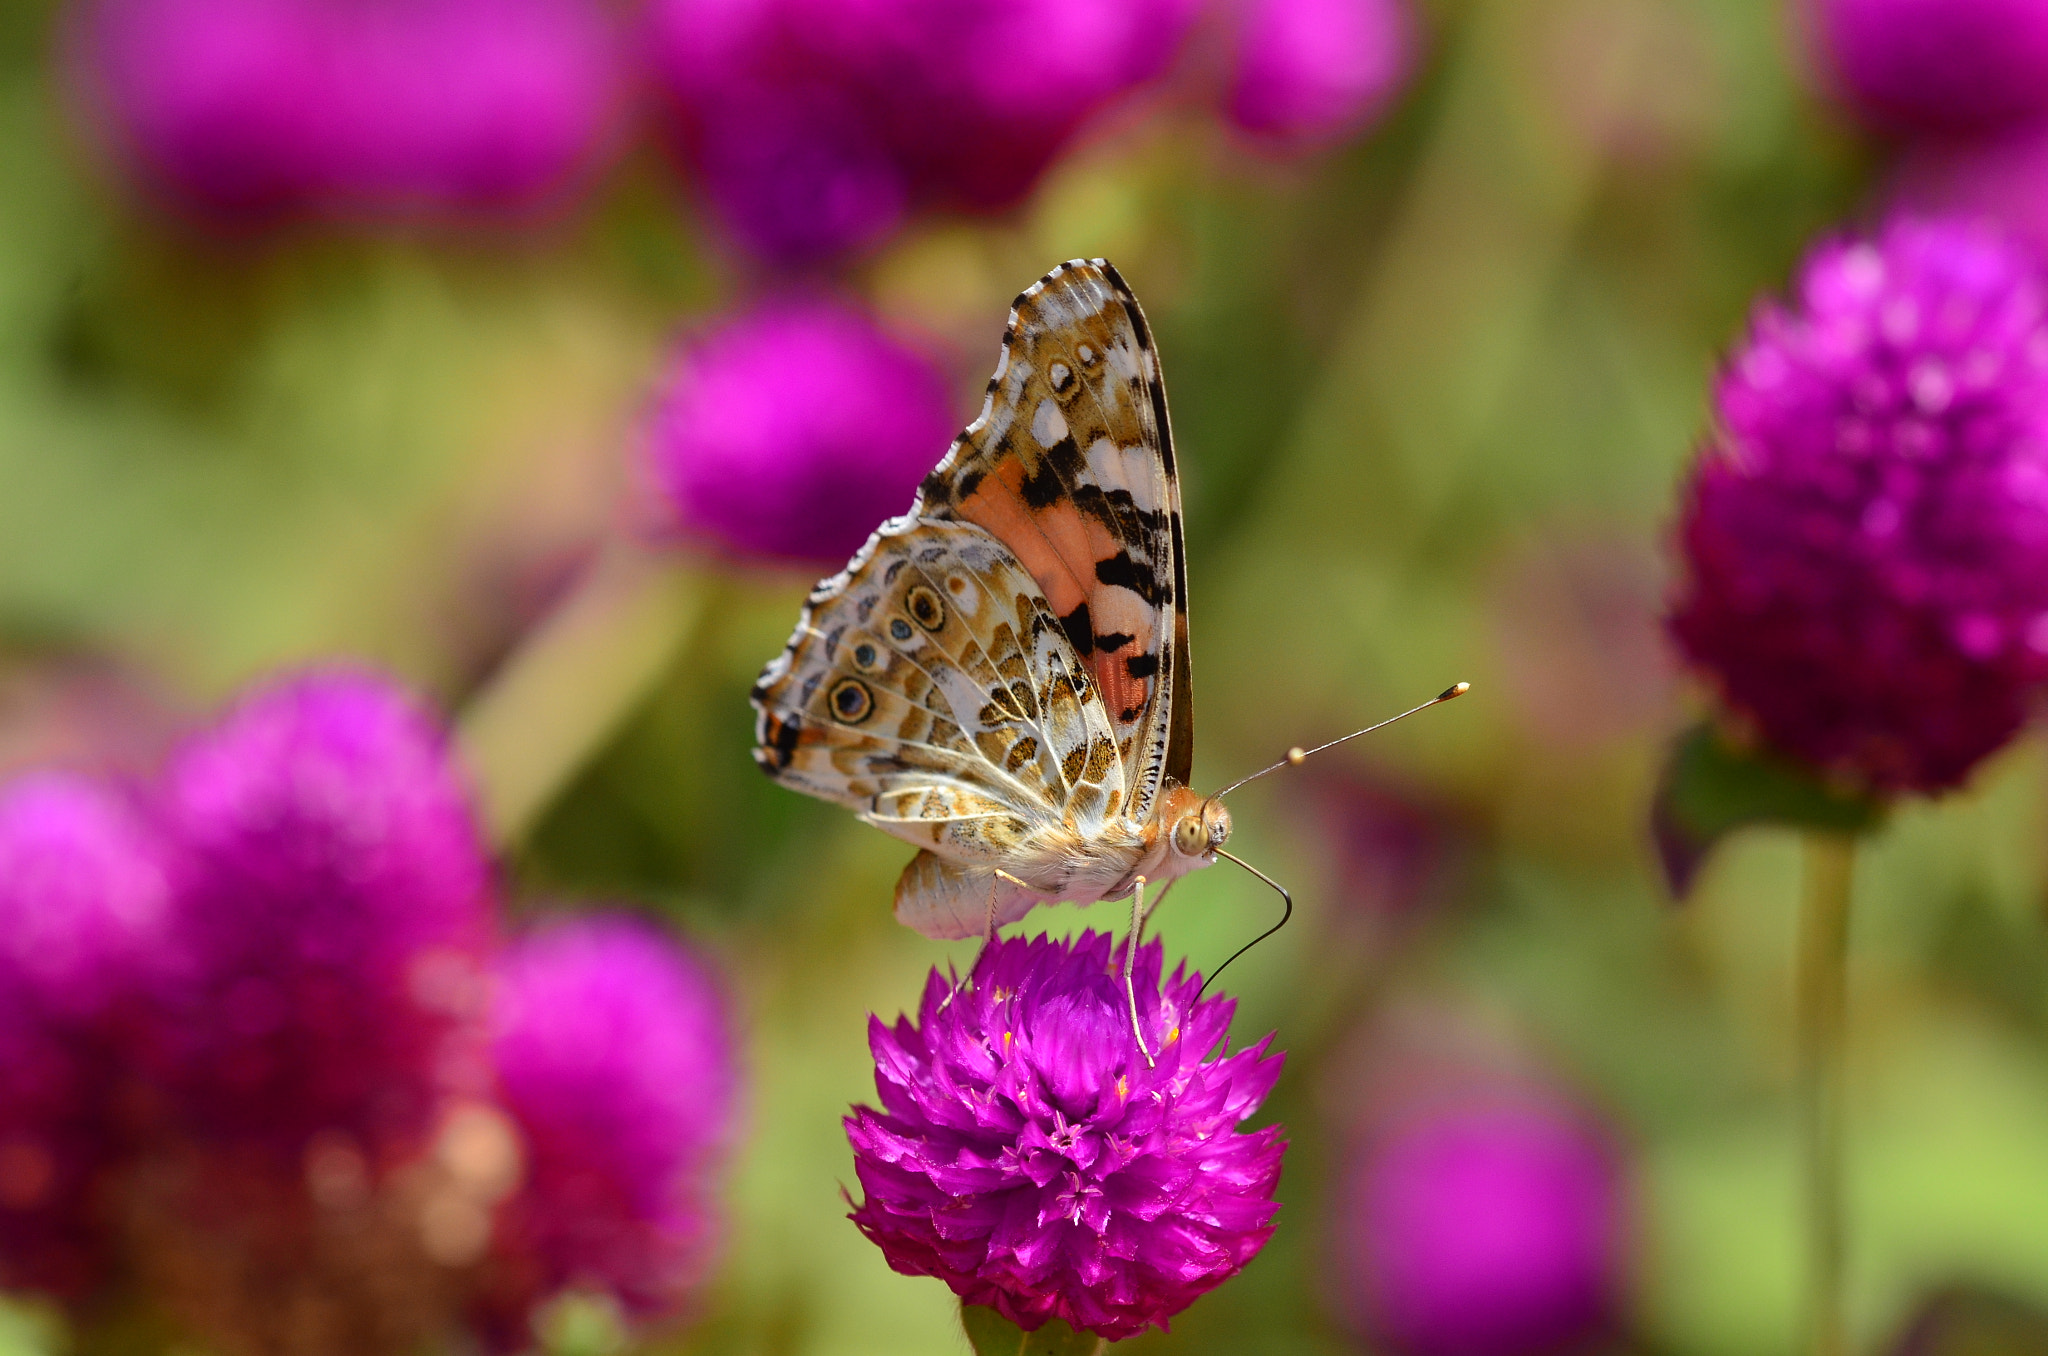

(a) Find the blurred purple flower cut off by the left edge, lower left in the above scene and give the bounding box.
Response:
[0,774,168,1297]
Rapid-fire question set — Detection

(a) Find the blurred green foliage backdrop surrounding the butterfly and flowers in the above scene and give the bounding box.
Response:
[0,0,2048,1356]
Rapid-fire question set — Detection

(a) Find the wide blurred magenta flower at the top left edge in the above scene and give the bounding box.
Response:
[74,0,621,219]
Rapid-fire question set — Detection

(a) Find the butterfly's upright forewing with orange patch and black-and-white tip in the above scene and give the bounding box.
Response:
[911,260,1194,819]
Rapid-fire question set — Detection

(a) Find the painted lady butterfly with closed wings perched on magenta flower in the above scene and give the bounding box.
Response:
[752,258,1231,966]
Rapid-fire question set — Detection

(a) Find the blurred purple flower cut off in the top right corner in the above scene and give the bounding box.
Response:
[1808,0,2048,133]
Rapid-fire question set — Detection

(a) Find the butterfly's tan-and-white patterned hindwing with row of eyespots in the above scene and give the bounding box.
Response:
[754,518,1126,864]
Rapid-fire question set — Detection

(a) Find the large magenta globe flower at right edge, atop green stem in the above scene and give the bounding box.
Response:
[1671,219,2048,793]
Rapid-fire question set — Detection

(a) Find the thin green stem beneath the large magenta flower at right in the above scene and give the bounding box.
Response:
[1798,830,1855,1356]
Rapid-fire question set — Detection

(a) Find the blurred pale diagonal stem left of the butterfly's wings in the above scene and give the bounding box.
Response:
[455,539,705,846]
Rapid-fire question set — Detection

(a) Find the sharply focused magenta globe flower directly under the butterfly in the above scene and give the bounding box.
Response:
[846,932,1284,1340]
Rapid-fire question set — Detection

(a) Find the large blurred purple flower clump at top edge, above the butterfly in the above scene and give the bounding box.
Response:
[647,0,1194,264]
